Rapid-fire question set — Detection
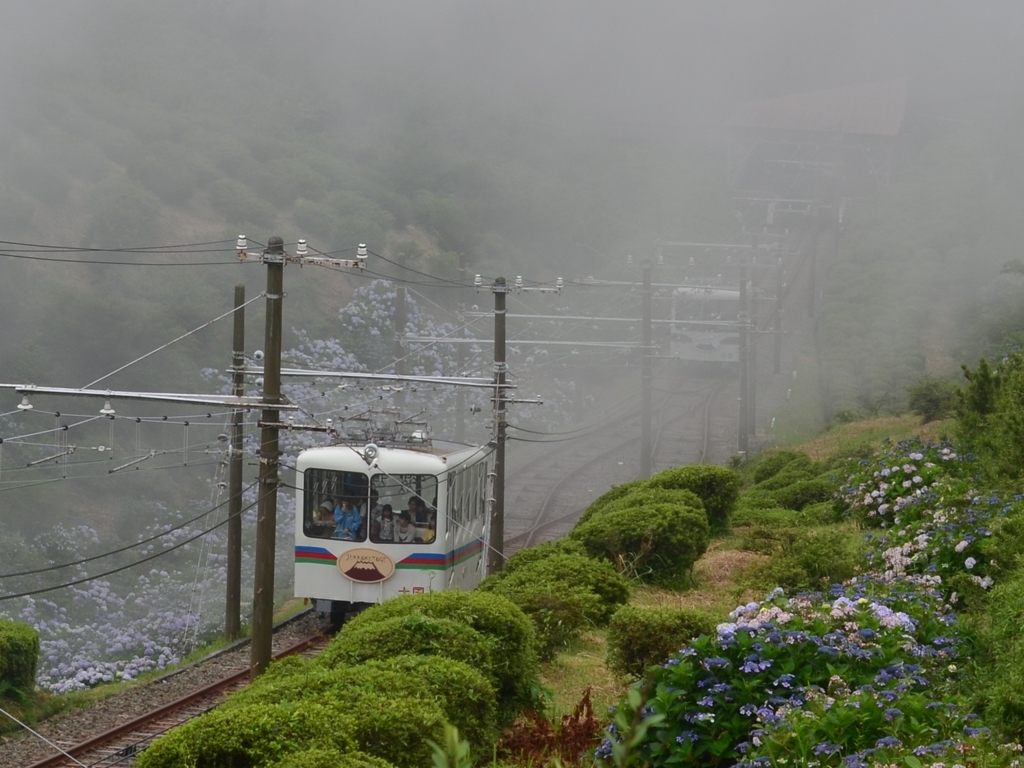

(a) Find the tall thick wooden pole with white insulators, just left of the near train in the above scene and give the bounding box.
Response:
[249,237,286,679]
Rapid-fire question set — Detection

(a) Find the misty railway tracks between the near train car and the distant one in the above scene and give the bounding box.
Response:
[505,370,724,554]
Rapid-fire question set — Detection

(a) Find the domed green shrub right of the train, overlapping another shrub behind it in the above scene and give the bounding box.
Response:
[569,504,709,584]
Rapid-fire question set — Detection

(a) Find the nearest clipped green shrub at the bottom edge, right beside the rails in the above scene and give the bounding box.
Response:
[135,702,366,768]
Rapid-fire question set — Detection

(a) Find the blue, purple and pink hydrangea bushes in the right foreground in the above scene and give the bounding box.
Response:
[597,442,1021,768]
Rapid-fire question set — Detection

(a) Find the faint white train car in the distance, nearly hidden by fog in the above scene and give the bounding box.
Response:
[670,286,739,369]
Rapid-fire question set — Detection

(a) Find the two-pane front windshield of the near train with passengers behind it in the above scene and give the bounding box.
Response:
[302,469,437,544]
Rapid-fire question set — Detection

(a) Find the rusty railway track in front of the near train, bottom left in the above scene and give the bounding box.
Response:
[14,614,330,768]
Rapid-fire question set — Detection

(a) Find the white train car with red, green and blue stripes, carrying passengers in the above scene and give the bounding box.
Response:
[295,441,494,622]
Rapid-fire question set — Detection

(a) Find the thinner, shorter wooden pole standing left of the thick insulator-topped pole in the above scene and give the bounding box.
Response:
[224,284,246,641]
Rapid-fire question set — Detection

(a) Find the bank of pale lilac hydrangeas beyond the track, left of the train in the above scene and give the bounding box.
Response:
[0,496,294,693]
